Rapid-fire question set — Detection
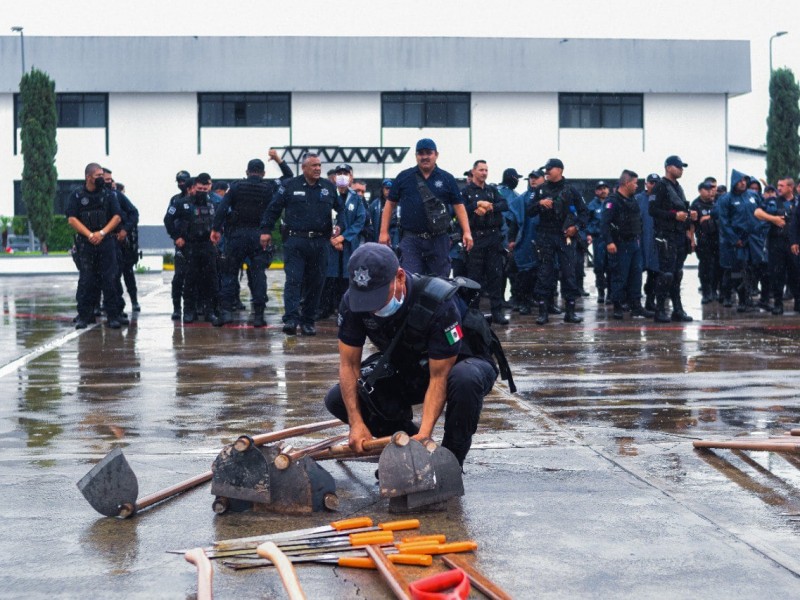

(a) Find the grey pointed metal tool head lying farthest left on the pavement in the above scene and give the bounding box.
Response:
[78,448,139,517]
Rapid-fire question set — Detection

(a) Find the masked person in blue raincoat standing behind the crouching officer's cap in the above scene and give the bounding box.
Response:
[317,164,367,319]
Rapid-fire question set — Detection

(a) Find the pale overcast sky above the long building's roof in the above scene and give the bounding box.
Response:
[0,0,800,148]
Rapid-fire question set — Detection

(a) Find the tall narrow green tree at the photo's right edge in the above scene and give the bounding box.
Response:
[767,69,800,184]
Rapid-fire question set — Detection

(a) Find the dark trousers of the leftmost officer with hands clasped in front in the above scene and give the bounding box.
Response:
[77,236,120,322]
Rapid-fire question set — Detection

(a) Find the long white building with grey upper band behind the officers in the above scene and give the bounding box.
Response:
[0,36,750,247]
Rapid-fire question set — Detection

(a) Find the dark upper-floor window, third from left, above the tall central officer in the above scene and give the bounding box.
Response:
[381,92,470,127]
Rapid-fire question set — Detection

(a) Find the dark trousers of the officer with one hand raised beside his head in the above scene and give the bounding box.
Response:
[219,228,272,311]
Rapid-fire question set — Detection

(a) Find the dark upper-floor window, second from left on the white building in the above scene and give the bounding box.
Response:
[197,93,291,127]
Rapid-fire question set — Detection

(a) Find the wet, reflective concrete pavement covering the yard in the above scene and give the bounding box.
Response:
[0,270,800,599]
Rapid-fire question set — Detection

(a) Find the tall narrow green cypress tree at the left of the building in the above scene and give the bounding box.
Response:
[19,69,58,254]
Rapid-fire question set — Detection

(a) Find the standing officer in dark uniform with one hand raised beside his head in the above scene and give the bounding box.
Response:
[210,149,292,327]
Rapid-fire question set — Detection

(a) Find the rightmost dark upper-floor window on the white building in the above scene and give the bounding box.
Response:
[558,94,643,129]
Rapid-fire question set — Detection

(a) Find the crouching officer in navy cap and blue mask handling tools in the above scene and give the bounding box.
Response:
[325,244,497,464]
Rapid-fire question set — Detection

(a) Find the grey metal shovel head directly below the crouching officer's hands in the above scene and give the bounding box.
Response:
[378,432,436,498]
